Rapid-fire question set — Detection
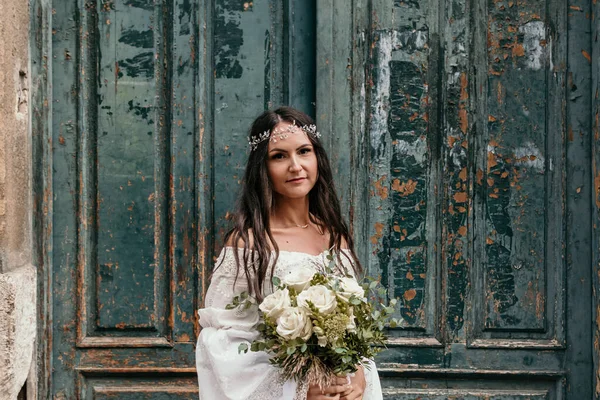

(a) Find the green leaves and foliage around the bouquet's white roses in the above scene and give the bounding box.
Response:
[227,250,402,379]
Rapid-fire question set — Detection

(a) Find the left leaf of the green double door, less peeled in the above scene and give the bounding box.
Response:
[38,0,315,399]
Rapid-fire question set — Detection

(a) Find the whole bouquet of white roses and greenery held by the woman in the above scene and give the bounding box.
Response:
[227,255,399,387]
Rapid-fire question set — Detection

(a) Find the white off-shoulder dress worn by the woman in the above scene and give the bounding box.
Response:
[196,247,383,400]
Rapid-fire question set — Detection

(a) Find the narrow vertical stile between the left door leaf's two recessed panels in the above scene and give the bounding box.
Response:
[168,0,199,343]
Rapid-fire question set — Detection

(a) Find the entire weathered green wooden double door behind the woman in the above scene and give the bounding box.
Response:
[33,0,597,400]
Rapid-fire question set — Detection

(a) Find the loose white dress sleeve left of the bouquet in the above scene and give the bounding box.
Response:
[196,248,284,400]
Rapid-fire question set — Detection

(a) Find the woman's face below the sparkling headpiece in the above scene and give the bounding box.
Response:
[267,122,318,199]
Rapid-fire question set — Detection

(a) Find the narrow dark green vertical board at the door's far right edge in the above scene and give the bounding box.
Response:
[568,0,598,399]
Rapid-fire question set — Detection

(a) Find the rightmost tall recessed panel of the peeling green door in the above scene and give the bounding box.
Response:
[471,1,566,346]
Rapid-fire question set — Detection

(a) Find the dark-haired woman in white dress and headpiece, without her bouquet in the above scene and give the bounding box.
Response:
[196,107,382,400]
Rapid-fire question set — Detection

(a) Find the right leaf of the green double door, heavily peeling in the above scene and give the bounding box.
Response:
[317,0,600,400]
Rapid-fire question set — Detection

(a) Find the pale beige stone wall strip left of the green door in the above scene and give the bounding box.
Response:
[0,0,37,400]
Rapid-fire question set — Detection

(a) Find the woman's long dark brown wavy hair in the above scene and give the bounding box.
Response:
[224,107,362,301]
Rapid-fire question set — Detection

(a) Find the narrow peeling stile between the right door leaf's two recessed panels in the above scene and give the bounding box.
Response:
[439,0,478,342]
